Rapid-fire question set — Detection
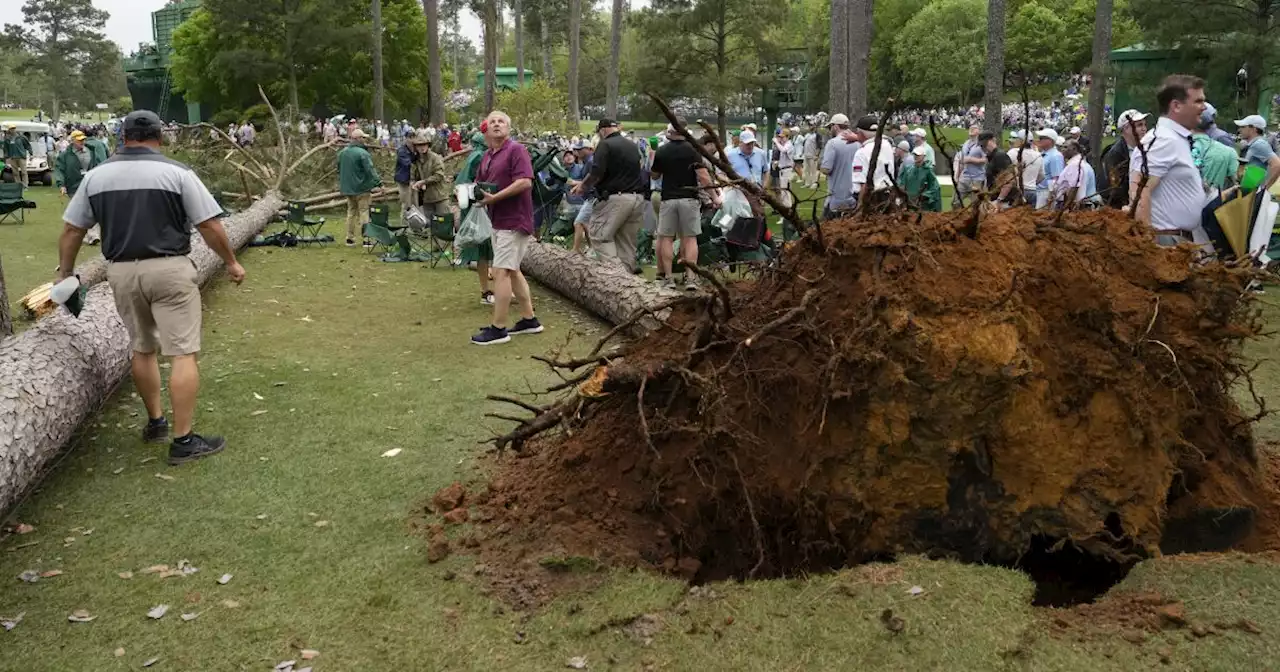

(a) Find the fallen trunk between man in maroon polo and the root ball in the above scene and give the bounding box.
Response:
[520,243,681,335]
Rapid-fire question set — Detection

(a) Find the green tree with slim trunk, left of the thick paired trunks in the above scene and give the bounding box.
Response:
[637,0,787,134]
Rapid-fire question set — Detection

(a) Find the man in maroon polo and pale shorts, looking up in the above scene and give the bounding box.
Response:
[471,110,543,346]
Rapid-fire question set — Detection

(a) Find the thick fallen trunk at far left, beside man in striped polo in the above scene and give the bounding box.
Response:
[0,192,284,512]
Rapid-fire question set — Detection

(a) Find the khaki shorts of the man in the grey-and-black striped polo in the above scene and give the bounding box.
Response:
[106,256,201,357]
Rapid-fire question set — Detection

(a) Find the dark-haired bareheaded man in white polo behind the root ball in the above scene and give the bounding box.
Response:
[1129,74,1204,246]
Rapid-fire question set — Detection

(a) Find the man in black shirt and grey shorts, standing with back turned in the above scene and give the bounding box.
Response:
[650,125,714,289]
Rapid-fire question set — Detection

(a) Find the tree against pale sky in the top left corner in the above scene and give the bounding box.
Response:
[4,0,113,119]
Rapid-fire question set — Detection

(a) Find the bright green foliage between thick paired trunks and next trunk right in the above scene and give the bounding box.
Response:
[893,0,987,104]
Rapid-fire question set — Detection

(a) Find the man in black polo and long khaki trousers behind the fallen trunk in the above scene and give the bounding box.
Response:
[572,119,649,273]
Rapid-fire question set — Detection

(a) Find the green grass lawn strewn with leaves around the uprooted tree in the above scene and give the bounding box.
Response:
[0,180,1280,672]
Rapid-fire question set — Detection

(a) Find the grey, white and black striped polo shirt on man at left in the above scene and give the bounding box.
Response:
[63,147,223,261]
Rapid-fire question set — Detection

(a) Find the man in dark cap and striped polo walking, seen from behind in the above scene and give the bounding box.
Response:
[58,110,244,465]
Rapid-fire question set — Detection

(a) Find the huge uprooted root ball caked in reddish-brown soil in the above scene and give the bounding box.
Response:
[483,210,1271,591]
